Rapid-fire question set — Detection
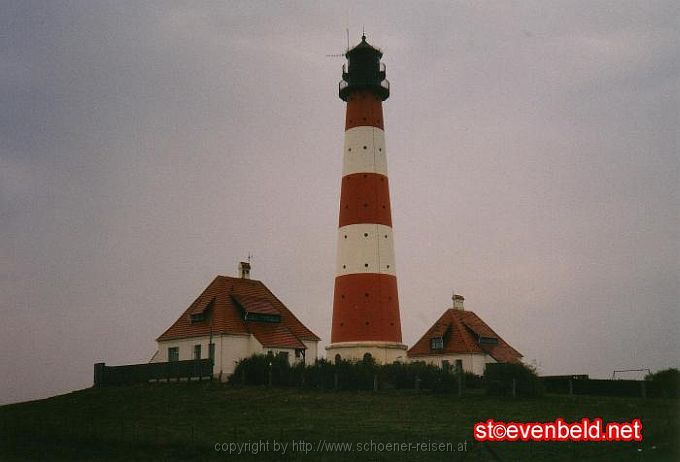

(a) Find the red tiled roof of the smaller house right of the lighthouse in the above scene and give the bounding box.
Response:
[407,308,522,363]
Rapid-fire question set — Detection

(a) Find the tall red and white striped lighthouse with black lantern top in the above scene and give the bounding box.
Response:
[326,36,406,363]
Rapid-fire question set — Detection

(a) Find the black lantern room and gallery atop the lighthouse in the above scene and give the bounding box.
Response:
[339,35,390,101]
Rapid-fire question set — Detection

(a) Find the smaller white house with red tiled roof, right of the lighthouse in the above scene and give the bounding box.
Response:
[407,294,522,375]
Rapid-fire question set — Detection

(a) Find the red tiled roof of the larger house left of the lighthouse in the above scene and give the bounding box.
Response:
[156,276,320,348]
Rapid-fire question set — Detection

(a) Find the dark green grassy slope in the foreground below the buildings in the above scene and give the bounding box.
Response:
[0,383,680,461]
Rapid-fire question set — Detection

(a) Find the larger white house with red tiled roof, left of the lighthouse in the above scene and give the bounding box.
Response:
[151,262,320,380]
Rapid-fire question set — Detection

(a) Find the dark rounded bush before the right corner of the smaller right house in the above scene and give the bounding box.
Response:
[484,363,543,396]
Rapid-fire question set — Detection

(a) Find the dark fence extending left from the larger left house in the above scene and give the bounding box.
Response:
[94,359,213,387]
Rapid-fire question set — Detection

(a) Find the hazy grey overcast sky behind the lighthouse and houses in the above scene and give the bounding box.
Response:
[0,0,680,403]
